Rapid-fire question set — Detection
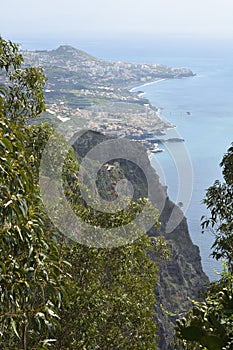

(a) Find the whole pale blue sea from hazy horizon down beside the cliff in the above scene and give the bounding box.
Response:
[19,38,233,280]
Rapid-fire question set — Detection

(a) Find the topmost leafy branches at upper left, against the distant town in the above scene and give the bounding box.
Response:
[0,39,46,122]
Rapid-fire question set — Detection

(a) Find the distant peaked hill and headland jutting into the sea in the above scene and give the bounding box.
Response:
[22,45,194,88]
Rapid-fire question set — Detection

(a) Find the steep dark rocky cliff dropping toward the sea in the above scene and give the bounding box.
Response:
[73,131,209,350]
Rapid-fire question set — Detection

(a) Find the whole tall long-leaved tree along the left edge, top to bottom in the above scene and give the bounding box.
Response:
[0,39,67,349]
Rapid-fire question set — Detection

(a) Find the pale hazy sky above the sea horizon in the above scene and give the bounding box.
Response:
[0,0,233,39]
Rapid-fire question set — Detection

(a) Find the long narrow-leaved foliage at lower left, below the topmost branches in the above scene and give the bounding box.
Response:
[0,117,68,349]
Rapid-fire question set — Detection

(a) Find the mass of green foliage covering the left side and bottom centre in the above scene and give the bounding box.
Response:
[0,37,166,350]
